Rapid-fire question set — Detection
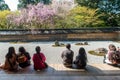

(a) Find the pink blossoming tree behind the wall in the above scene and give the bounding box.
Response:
[8,3,55,29]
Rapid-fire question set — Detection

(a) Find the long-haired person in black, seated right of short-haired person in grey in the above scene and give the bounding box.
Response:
[74,47,87,69]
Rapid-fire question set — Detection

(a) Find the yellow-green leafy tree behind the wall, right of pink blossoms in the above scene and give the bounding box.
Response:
[54,6,105,28]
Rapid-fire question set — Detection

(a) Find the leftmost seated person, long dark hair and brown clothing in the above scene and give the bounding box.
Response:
[0,47,18,71]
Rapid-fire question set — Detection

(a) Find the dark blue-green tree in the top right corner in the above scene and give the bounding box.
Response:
[99,0,120,27]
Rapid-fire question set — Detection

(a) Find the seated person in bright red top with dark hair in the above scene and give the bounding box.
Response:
[32,46,46,70]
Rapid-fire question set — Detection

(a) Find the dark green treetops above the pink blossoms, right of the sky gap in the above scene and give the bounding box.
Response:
[18,0,51,9]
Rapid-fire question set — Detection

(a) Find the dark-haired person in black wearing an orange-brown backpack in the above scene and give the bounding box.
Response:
[17,47,31,68]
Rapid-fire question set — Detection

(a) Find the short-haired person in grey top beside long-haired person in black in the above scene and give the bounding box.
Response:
[61,44,74,67]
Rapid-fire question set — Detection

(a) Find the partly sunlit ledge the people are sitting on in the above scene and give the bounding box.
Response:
[0,64,120,76]
